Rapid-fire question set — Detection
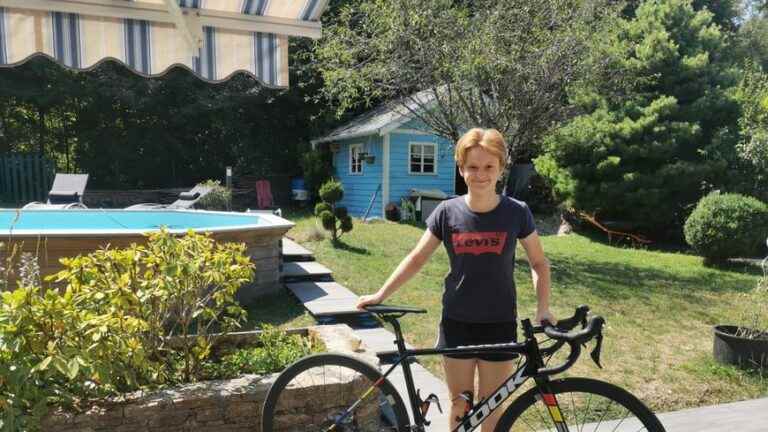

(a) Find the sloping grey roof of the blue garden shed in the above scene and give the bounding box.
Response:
[311,90,434,147]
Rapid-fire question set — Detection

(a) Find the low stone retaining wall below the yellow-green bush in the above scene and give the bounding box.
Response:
[43,325,376,432]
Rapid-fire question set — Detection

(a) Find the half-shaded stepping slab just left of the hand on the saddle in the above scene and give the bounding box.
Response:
[285,282,367,316]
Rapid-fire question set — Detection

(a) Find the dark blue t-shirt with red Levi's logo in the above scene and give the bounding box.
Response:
[427,196,536,322]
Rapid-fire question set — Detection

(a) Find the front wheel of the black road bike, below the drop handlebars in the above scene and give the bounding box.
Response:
[495,378,664,432]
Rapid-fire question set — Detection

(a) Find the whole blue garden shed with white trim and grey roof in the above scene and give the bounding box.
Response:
[312,99,463,218]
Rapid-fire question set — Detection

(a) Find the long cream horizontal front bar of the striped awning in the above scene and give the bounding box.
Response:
[0,0,322,39]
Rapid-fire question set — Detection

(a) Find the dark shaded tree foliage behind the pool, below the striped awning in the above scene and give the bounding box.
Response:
[0,46,336,189]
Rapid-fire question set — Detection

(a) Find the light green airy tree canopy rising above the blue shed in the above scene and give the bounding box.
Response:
[315,0,614,160]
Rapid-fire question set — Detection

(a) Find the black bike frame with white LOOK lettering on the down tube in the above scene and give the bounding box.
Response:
[384,319,567,432]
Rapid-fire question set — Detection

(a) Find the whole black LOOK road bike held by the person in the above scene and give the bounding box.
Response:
[262,305,664,432]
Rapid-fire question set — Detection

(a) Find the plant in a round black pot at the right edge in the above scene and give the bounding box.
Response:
[713,253,768,371]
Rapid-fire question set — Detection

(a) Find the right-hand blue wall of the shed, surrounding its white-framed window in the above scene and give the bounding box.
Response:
[389,121,456,205]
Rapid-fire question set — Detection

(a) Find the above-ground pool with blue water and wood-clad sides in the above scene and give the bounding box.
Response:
[0,209,293,297]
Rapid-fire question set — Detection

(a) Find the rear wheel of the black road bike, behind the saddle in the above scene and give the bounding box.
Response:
[261,354,409,432]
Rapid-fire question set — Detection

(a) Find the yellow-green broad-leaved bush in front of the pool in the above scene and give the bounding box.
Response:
[0,230,254,432]
